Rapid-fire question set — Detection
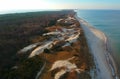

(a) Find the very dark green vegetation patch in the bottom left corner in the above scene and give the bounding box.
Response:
[1,56,44,79]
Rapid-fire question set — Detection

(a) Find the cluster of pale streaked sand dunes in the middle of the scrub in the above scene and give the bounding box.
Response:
[28,25,80,58]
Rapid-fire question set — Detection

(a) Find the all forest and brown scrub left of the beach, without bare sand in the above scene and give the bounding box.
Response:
[0,10,94,79]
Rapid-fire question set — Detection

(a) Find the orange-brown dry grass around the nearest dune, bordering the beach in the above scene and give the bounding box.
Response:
[39,16,94,79]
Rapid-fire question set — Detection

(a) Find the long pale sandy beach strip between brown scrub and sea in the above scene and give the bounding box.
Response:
[75,16,119,79]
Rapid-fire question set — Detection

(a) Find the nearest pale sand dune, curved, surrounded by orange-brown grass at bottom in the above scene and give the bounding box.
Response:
[50,57,82,79]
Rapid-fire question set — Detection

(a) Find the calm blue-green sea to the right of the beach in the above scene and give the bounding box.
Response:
[77,10,120,73]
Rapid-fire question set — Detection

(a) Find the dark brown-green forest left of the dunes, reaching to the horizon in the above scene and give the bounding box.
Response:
[0,10,74,79]
